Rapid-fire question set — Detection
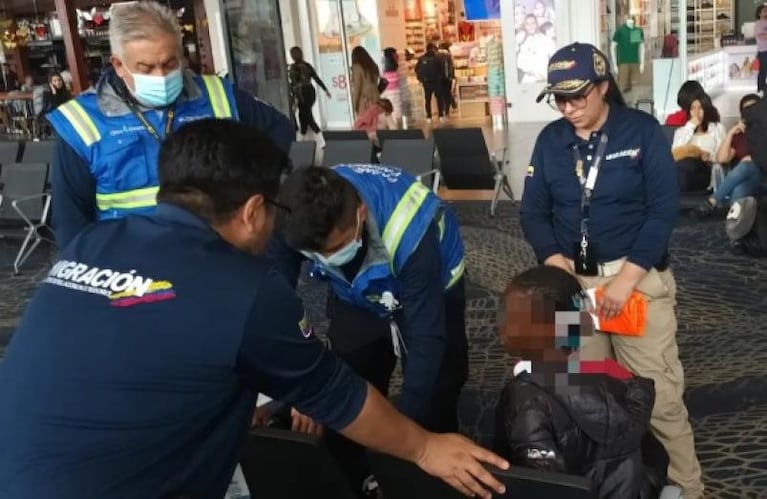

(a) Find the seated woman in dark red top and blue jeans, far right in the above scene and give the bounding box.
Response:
[698,94,762,216]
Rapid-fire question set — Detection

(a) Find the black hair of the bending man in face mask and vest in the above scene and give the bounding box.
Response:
[280,166,360,251]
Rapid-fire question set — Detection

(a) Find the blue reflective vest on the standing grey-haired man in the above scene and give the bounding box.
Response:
[47,75,238,219]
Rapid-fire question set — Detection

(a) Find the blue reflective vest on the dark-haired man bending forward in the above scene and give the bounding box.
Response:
[311,165,465,317]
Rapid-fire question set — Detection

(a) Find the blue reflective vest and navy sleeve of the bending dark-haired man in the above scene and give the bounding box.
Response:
[304,165,464,421]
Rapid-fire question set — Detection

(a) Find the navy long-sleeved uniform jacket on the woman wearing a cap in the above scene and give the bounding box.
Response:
[521,106,679,269]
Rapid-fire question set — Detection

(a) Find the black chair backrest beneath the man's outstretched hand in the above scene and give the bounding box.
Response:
[368,452,596,499]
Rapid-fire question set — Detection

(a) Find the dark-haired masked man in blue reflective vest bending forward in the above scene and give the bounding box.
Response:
[281,165,468,496]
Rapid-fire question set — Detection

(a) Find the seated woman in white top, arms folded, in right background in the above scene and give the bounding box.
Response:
[671,93,727,192]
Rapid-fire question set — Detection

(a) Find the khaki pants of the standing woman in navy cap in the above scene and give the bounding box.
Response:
[580,269,703,499]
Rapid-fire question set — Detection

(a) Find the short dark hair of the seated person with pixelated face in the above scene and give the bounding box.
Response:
[504,265,583,322]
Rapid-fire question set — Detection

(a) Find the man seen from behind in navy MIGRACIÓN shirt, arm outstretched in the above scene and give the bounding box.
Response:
[0,120,508,499]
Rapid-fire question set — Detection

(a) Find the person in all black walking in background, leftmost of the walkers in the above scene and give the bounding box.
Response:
[288,47,331,147]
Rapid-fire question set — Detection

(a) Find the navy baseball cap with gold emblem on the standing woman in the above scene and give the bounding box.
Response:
[535,42,610,102]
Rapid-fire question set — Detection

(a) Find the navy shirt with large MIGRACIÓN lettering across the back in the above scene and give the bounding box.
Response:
[0,204,367,499]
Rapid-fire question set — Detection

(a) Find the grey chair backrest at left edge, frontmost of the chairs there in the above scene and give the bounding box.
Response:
[0,163,48,221]
